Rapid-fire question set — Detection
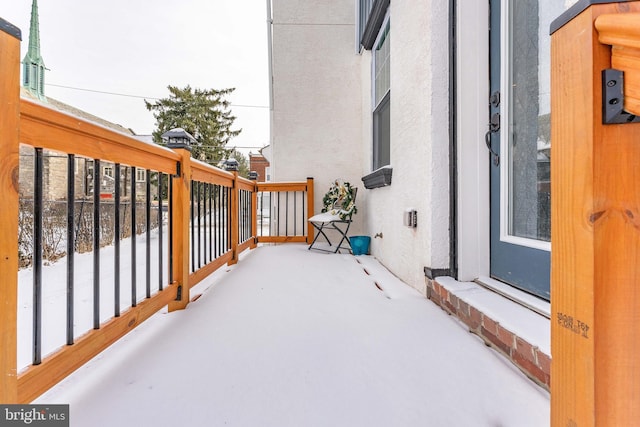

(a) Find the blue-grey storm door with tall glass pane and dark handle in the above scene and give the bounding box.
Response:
[485,0,570,300]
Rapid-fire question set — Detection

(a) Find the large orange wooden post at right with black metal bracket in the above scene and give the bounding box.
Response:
[551,0,640,427]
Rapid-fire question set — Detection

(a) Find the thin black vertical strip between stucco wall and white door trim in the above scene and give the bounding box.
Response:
[449,0,458,279]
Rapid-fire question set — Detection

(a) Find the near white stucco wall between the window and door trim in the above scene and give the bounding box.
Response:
[365,0,449,290]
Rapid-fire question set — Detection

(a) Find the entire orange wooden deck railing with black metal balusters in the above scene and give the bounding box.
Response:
[0,25,313,403]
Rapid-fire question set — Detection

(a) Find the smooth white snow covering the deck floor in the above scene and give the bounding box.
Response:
[34,244,549,427]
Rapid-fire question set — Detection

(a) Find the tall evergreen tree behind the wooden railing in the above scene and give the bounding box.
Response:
[144,86,242,165]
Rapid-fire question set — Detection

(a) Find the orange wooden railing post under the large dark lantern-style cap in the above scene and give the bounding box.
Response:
[169,148,191,311]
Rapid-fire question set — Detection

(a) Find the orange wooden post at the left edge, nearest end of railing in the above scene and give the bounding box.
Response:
[0,18,21,404]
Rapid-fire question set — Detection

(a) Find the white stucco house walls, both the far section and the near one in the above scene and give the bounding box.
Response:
[272,0,449,292]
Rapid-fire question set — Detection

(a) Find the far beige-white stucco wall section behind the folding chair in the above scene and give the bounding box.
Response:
[272,0,366,233]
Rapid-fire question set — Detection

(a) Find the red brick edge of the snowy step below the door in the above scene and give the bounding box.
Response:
[427,279,551,390]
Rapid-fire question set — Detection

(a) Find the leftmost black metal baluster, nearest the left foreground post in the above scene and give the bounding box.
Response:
[33,148,44,365]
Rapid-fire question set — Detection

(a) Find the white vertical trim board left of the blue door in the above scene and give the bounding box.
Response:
[456,2,490,282]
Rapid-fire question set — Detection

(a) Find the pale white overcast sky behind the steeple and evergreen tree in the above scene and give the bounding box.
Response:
[0,0,269,154]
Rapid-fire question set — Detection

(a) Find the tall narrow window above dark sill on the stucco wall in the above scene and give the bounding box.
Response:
[372,16,391,170]
